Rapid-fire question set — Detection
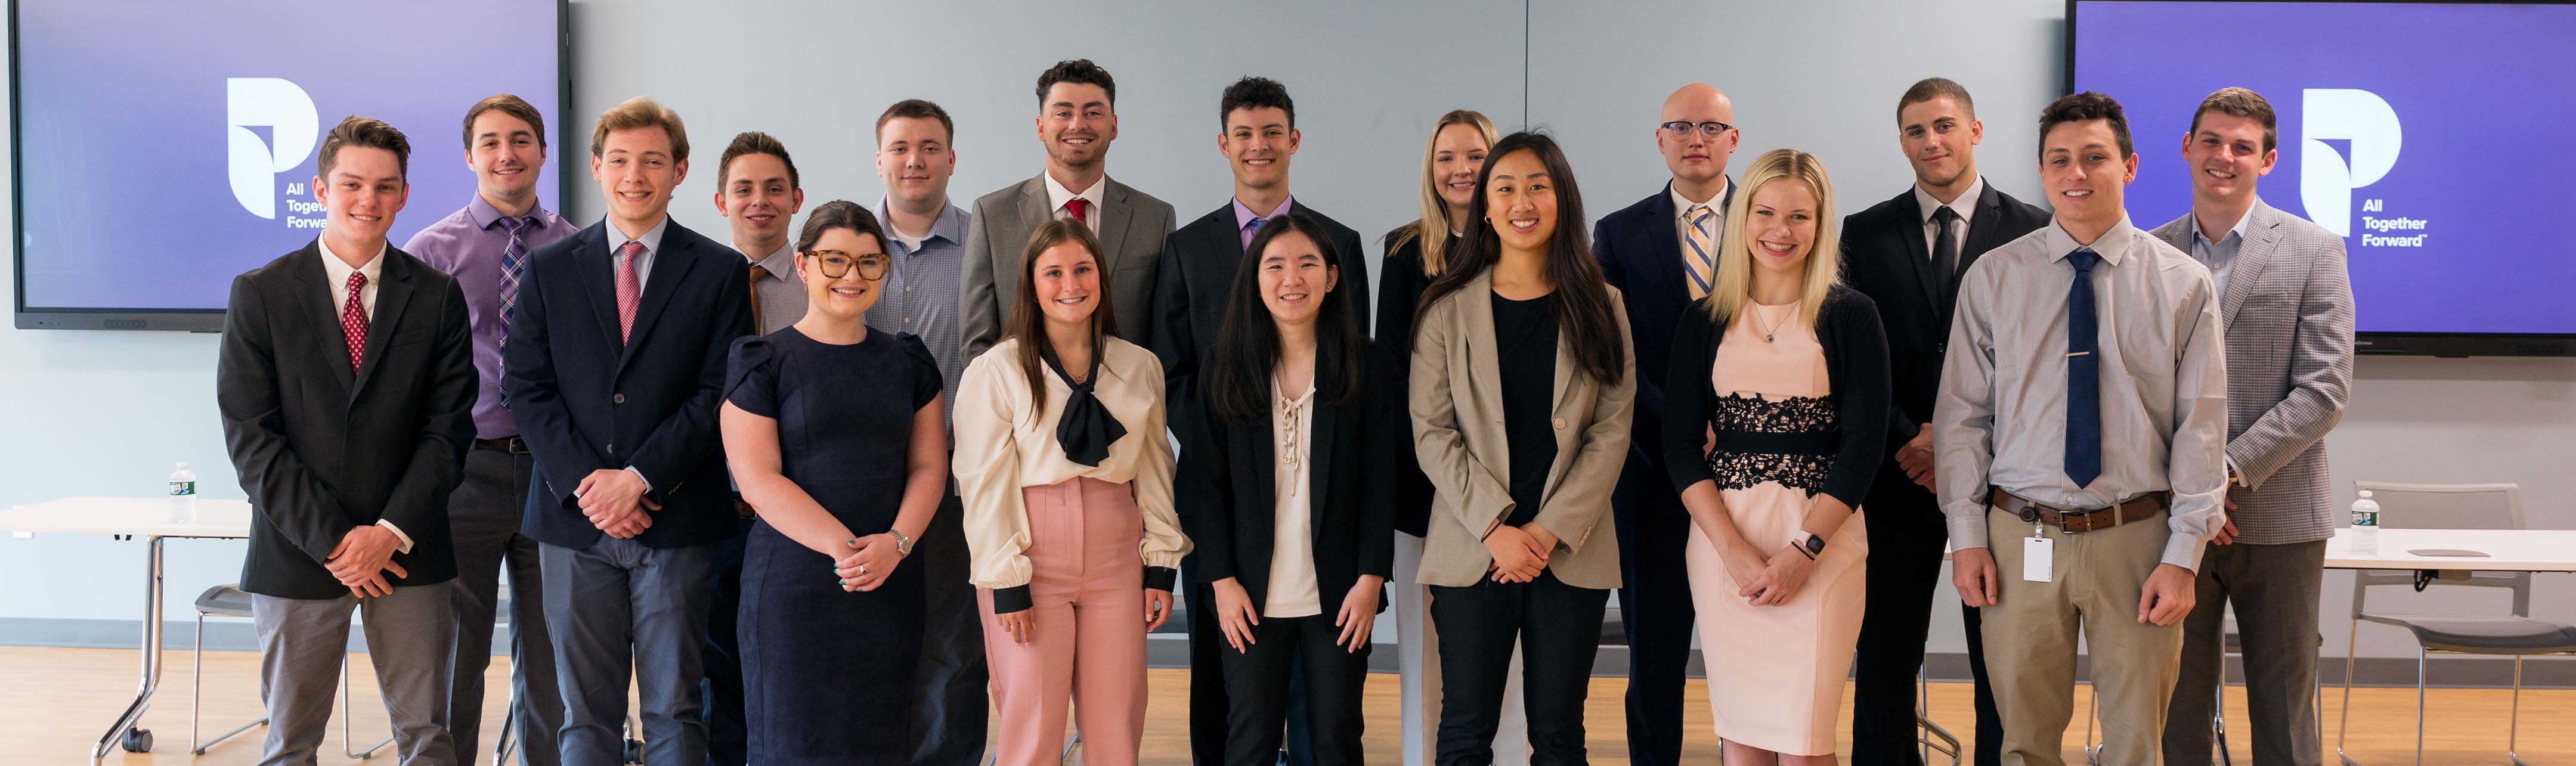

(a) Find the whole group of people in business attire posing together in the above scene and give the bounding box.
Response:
[219,60,2352,766]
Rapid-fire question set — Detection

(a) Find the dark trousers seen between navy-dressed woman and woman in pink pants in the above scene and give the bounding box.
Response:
[912,495,992,766]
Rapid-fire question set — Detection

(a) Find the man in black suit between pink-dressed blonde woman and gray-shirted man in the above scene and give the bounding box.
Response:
[1842,77,2048,766]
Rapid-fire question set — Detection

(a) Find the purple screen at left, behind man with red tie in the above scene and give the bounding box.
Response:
[16,0,564,309]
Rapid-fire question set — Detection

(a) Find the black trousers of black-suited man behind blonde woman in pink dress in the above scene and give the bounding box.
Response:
[1852,461,2004,766]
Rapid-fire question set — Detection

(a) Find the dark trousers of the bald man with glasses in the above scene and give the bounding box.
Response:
[1610,457,1695,766]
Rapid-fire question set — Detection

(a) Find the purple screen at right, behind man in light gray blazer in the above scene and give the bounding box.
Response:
[2074,0,2576,333]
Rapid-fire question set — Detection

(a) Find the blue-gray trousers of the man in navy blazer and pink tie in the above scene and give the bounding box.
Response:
[538,536,716,766]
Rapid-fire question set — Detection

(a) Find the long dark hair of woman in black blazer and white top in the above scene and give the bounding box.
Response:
[1208,212,1368,420]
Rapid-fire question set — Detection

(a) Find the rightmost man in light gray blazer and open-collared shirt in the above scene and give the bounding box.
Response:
[2154,88,2352,766]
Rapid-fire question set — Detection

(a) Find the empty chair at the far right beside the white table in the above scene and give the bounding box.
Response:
[2334,482,2576,766]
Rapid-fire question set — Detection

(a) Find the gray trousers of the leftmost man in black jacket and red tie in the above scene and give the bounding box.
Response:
[250,583,456,766]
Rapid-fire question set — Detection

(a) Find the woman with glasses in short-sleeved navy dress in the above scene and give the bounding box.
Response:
[722,201,948,764]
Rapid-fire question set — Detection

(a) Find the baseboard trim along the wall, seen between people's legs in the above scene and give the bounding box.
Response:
[15,616,2576,689]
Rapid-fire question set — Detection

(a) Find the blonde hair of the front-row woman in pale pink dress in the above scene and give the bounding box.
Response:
[1708,150,1842,327]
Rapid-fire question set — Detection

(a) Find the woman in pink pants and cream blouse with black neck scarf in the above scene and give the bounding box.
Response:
[956,222,1190,766]
